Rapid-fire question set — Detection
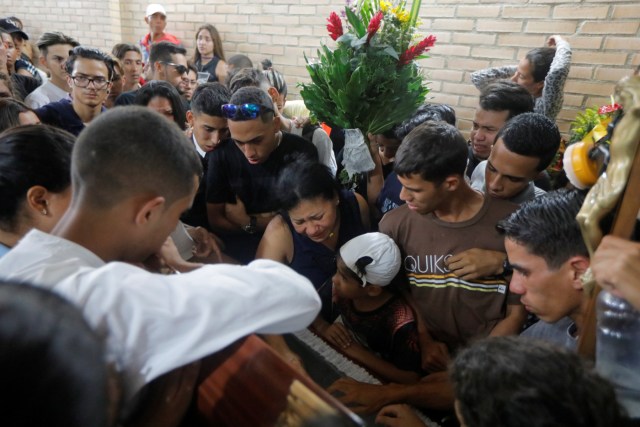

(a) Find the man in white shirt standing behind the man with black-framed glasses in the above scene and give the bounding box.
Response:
[24,32,79,109]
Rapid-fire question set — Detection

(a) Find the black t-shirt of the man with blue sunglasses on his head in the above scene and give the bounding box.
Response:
[207,132,318,214]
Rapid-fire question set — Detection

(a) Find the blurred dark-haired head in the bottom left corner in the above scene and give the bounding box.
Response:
[0,280,110,427]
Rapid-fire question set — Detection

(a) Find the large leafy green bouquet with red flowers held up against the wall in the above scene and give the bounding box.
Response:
[300,0,436,143]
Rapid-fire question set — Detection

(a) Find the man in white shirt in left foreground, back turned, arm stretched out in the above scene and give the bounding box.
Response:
[0,107,320,418]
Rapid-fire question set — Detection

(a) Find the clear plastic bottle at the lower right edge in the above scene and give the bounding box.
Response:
[596,291,640,418]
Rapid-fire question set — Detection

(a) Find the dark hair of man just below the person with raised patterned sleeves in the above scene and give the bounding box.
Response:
[480,80,535,120]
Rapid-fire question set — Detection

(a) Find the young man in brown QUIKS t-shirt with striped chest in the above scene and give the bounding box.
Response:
[330,122,526,412]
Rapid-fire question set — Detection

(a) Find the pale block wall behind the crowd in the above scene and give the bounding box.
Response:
[0,0,640,137]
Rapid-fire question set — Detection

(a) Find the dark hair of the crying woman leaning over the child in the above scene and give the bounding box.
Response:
[276,158,340,211]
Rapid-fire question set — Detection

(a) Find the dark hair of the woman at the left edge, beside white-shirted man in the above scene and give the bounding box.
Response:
[0,125,75,232]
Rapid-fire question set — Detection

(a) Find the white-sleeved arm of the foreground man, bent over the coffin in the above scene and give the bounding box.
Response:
[79,260,321,398]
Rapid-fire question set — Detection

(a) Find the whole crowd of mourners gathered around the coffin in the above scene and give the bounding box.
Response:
[0,4,640,427]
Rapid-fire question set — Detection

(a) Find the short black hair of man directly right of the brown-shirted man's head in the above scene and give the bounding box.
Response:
[496,113,560,171]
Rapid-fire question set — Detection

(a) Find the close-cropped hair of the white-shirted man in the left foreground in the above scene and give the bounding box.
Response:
[71,106,202,208]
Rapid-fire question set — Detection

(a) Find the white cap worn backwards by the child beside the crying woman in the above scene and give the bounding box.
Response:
[340,233,401,286]
